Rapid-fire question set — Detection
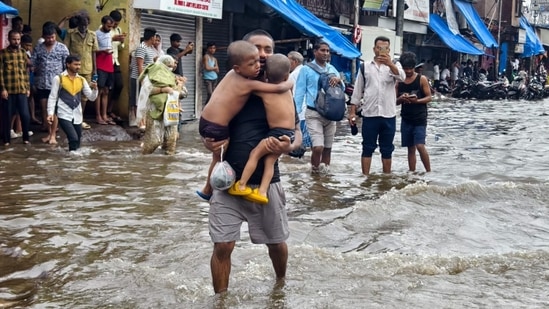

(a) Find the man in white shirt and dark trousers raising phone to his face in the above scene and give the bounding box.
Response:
[348,36,406,175]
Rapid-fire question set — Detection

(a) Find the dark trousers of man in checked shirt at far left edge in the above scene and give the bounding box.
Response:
[0,93,30,143]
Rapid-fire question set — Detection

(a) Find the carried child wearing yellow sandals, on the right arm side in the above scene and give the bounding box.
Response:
[228,54,295,204]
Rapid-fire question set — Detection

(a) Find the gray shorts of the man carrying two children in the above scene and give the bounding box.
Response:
[208,182,290,244]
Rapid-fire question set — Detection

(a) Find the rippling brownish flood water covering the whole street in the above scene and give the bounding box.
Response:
[0,100,549,309]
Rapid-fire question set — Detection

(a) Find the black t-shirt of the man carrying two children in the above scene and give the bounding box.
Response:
[224,95,299,185]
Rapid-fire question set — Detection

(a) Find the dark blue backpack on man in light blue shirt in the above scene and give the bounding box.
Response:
[307,63,345,121]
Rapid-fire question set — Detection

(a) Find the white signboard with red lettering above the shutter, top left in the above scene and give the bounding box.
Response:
[133,0,223,19]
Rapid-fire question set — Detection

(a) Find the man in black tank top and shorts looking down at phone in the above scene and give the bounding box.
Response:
[397,52,431,172]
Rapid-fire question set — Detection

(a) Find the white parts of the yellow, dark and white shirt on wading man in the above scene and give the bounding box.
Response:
[48,71,98,124]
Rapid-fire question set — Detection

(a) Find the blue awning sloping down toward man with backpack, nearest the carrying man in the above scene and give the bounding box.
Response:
[261,0,361,59]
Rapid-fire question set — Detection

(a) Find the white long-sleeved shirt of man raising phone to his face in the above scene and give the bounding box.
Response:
[351,61,406,118]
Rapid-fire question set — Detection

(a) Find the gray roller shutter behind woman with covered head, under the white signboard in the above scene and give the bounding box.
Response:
[141,11,200,120]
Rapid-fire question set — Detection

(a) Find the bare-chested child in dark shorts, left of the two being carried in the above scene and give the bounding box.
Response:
[196,41,293,200]
